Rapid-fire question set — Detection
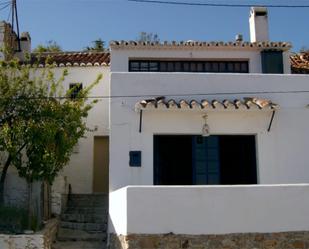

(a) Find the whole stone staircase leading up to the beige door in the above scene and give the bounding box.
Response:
[53,194,108,249]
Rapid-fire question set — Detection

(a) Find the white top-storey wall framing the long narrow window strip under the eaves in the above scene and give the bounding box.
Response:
[111,48,291,74]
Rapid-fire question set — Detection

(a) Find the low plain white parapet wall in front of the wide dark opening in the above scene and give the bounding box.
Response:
[109,184,309,235]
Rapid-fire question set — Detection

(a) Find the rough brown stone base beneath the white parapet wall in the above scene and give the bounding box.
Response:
[110,232,309,249]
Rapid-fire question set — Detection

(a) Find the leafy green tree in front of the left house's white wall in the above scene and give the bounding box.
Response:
[0,57,102,210]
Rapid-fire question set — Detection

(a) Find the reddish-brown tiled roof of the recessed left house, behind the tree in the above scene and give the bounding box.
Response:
[31,52,110,67]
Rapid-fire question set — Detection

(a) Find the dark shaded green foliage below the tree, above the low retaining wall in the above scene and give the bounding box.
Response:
[0,206,27,234]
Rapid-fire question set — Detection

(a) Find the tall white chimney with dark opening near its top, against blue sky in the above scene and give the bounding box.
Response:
[249,7,269,42]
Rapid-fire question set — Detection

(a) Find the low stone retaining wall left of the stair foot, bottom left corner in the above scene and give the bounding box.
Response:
[0,219,59,249]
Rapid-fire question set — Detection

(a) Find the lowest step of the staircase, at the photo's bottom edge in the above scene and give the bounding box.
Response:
[52,241,107,249]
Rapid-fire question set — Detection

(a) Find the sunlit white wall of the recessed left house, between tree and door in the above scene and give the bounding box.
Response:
[57,66,110,193]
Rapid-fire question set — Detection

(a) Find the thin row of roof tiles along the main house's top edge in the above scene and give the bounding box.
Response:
[110,41,292,50]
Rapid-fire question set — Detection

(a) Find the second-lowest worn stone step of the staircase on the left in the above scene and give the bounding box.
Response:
[57,227,107,242]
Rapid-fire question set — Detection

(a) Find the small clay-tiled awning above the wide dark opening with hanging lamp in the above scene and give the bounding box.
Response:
[135,97,279,111]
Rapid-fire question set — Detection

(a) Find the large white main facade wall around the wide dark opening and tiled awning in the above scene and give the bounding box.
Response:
[109,73,309,191]
